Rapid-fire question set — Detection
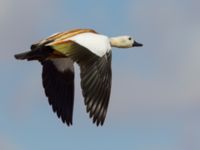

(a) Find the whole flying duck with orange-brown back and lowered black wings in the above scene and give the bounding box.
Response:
[15,29,142,126]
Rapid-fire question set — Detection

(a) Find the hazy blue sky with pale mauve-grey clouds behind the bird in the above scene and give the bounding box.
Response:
[0,0,200,150]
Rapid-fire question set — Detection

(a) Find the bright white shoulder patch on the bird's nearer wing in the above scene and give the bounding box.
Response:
[66,33,111,57]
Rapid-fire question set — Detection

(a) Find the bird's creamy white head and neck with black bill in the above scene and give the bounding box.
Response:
[110,36,143,48]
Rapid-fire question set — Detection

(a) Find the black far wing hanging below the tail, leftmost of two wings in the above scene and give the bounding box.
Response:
[42,58,74,126]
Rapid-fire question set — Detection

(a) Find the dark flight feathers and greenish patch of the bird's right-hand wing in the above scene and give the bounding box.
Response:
[49,40,112,125]
